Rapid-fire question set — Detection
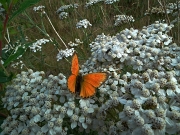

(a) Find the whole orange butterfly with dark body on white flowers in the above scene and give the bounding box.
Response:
[68,54,108,98]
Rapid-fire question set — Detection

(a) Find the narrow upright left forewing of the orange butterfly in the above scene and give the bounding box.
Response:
[71,53,79,76]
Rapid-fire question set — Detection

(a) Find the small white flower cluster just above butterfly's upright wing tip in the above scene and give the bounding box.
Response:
[56,48,74,61]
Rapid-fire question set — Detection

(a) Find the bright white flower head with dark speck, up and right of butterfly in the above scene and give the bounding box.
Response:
[90,34,129,62]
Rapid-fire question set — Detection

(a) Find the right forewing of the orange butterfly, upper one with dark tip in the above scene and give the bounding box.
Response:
[83,72,108,88]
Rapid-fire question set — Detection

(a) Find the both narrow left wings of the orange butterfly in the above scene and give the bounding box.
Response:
[68,54,79,93]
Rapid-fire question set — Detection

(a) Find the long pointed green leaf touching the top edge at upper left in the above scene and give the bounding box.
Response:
[9,0,41,22]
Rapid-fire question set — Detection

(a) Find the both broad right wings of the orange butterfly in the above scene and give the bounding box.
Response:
[80,73,108,98]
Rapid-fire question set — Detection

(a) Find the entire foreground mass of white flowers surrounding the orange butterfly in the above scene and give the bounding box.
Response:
[1,22,180,135]
